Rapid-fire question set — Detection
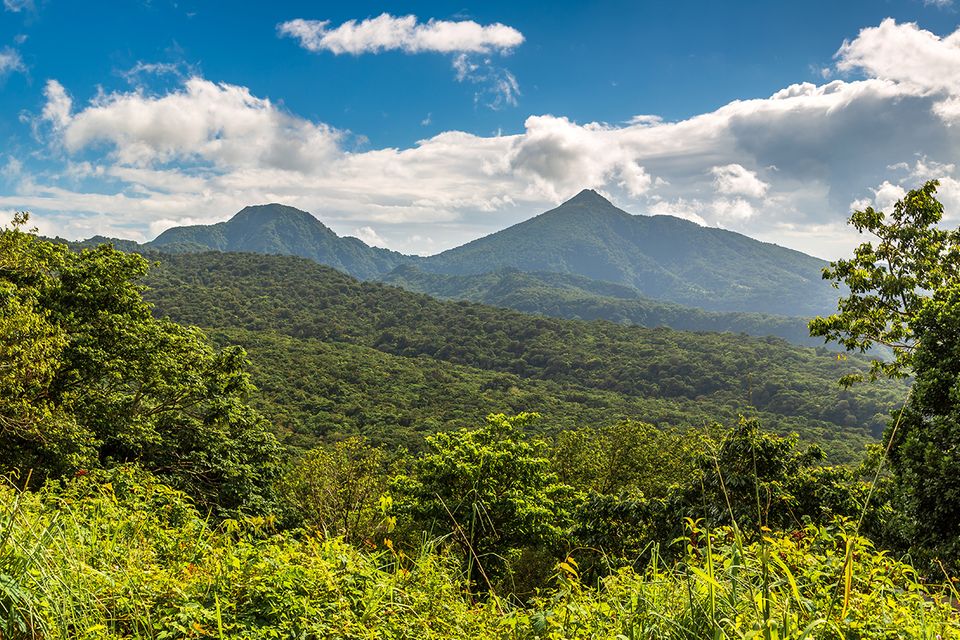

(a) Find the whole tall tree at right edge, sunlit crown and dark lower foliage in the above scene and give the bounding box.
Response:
[810,181,960,568]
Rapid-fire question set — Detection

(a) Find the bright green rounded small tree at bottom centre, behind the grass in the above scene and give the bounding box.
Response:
[401,413,570,585]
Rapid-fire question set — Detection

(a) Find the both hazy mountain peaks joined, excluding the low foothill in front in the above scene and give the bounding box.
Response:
[73,189,838,317]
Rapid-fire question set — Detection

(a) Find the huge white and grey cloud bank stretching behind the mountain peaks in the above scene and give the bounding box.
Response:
[11,21,960,258]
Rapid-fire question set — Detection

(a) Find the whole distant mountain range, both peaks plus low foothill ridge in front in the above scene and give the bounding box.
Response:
[73,190,838,344]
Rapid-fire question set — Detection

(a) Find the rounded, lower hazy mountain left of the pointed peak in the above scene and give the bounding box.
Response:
[143,204,416,279]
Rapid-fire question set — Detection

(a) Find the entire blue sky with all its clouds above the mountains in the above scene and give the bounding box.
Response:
[0,0,960,259]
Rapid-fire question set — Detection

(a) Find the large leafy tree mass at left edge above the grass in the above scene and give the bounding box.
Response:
[0,214,279,510]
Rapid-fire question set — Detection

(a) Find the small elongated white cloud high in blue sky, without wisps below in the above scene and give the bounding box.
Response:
[277,13,523,55]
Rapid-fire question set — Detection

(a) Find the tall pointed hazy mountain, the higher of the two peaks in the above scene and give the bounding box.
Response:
[419,190,838,316]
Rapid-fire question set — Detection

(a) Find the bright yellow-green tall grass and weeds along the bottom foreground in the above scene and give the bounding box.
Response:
[0,469,960,640]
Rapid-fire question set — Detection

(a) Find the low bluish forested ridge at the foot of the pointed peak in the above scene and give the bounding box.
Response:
[380,265,823,346]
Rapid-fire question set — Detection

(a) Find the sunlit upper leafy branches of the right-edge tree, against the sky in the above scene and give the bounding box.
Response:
[810,180,960,385]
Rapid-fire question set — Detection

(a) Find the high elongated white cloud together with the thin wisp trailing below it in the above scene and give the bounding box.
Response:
[277,13,524,109]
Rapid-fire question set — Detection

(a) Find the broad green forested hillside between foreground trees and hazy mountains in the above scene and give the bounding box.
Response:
[147,253,903,456]
